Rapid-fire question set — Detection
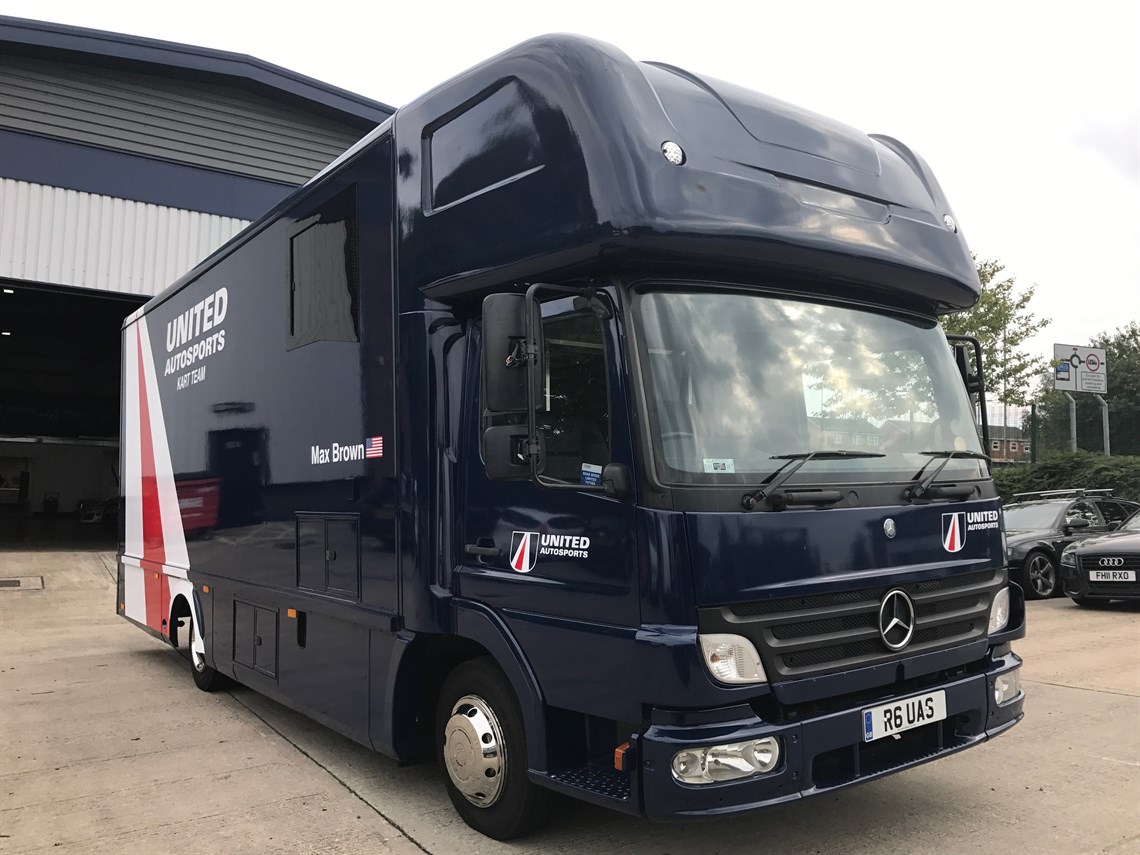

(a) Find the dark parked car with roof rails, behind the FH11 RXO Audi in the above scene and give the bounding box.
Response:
[1003,490,1140,600]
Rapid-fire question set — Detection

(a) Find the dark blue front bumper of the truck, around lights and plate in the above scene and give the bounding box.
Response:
[637,644,1025,820]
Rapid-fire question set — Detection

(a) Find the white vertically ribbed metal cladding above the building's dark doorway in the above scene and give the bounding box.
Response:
[0,178,249,295]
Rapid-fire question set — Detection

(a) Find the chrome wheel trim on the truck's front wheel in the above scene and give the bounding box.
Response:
[443,694,506,807]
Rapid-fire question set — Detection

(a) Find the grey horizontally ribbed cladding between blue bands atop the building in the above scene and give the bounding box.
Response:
[0,56,364,185]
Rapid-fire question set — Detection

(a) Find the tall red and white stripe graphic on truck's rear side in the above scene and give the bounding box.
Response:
[122,317,189,635]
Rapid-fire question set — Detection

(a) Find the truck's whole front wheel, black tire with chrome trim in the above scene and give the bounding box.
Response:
[435,657,551,840]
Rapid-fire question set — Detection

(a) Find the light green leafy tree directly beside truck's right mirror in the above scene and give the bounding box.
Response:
[942,255,1049,406]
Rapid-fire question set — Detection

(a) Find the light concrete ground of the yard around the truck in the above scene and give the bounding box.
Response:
[0,552,1140,855]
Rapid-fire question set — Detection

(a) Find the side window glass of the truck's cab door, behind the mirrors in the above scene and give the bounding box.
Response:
[538,314,610,485]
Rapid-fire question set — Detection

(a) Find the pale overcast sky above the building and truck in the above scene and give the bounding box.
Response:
[0,0,1140,373]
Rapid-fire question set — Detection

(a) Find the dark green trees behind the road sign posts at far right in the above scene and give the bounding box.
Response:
[1026,320,1140,455]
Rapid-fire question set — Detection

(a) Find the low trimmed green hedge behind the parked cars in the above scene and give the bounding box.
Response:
[994,451,1140,503]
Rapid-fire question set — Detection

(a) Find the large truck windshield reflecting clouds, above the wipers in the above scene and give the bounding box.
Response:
[637,291,986,485]
